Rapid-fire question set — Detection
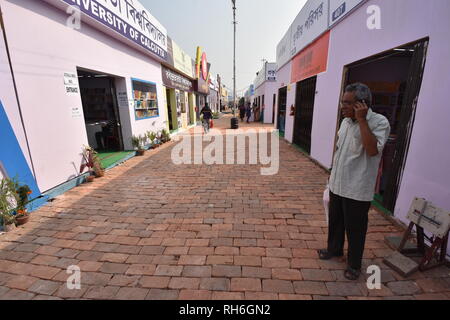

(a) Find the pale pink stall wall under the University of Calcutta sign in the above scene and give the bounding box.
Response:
[0,0,166,190]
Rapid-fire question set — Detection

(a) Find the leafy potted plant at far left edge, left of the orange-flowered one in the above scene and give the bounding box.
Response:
[0,178,19,232]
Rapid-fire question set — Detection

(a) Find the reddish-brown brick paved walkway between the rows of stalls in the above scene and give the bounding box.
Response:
[0,116,450,300]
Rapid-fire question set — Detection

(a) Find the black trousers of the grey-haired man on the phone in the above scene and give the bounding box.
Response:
[328,191,371,270]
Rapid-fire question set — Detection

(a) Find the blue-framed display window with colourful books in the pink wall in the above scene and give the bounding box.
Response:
[132,79,159,120]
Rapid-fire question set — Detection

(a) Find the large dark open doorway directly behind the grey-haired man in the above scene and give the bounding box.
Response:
[340,39,428,213]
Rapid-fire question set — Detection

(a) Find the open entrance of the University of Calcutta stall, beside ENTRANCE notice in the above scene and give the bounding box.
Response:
[78,69,124,152]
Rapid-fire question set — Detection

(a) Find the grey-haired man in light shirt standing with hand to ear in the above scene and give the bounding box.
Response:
[318,83,391,280]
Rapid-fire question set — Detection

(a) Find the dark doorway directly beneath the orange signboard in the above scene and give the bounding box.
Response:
[293,76,317,154]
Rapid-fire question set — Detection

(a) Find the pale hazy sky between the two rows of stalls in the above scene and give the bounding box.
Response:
[140,0,306,95]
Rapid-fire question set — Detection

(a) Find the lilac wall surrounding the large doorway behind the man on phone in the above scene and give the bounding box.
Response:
[312,0,450,240]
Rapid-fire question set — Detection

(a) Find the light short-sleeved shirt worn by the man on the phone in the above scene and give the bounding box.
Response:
[329,109,391,201]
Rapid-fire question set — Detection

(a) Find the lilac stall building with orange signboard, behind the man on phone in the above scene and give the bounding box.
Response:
[277,0,450,255]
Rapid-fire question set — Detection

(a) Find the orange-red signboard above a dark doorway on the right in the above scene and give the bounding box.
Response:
[291,31,330,83]
